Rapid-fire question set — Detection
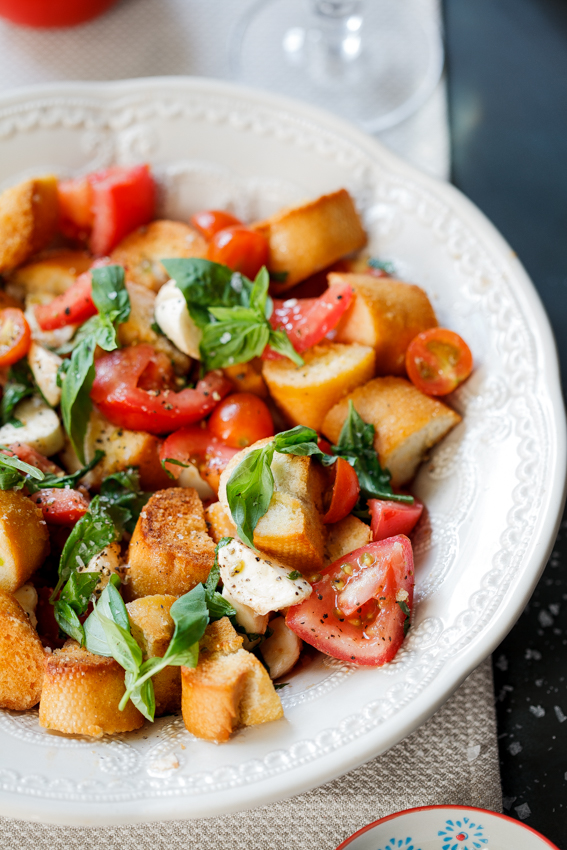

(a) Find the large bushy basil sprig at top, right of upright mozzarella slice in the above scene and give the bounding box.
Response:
[162,259,303,372]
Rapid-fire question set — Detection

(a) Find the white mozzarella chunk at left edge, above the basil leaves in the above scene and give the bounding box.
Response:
[0,396,65,457]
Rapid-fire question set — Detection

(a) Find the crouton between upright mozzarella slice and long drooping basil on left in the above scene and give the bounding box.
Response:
[118,281,191,375]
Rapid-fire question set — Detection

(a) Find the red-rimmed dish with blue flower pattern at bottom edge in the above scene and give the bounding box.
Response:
[337,806,559,850]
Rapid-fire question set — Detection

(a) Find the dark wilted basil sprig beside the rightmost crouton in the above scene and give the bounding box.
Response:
[332,400,414,510]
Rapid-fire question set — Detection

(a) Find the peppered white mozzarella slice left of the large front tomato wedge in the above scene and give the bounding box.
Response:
[219,539,311,614]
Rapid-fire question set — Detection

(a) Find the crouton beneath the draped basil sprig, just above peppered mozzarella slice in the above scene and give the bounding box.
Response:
[219,438,324,573]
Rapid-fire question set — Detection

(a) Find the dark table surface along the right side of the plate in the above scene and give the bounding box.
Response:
[444,0,567,850]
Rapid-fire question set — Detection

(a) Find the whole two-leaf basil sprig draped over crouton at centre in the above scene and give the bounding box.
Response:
[226,425,336,548]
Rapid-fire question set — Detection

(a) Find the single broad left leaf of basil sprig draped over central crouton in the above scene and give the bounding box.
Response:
[226,442,275,548]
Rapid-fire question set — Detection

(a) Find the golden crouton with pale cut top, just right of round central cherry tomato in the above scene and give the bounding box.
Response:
[263,342,375,431]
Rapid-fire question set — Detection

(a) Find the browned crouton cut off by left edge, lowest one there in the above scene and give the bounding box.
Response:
[0,590,44,711]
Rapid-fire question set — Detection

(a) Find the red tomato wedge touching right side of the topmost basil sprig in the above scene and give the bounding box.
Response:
[263,283,354,360]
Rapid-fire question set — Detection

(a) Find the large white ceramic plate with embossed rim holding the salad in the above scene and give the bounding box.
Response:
[0,78,565,826]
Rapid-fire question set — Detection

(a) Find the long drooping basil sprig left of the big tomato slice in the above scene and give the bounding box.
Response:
[61,265,130,463]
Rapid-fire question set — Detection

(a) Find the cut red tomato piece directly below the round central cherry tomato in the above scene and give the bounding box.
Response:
[159,428,239,492]
